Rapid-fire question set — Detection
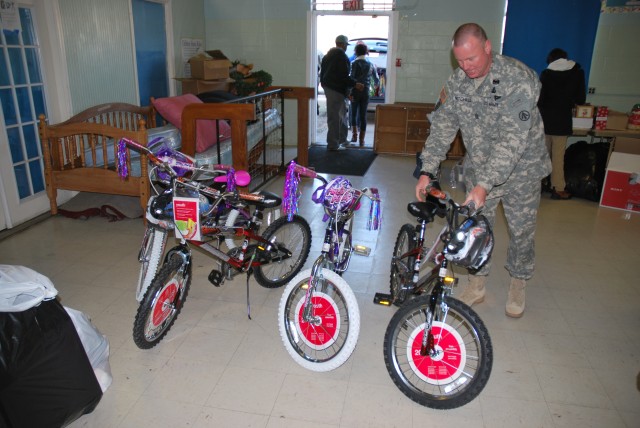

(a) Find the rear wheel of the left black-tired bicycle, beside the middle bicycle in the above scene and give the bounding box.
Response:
[254,215,311,288]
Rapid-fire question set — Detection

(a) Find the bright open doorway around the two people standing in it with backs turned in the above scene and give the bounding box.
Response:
[311,11,391,149]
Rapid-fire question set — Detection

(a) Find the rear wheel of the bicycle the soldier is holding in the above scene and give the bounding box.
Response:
[389,224,418,306]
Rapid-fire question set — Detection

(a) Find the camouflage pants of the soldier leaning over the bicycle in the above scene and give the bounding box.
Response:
[476,181,540,280]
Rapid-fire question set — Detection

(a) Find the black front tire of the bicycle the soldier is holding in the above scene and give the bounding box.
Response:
[384,294,493,409]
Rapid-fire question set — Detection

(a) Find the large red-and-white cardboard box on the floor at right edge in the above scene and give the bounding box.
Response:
[600,151,640,212]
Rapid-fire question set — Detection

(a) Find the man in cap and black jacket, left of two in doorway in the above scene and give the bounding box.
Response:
[320,35,363,151]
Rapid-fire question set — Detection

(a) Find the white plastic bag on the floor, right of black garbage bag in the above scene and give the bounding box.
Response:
[64,306,113,393]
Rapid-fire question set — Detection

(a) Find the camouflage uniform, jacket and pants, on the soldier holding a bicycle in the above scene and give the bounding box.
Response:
[421,54,551,280]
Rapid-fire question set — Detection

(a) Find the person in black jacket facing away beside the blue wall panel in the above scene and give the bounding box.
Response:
[538,48,586,199]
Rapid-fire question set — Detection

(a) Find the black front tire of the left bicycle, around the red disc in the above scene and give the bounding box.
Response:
[133,253,191,349]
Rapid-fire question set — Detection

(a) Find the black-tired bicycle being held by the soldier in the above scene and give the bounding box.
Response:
[374,187,493,409]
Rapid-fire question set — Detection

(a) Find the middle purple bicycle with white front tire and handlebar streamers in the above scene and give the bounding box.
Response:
[278,162,381,372]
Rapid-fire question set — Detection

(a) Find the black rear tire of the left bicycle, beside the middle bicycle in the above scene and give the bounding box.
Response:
[254,215,311,288]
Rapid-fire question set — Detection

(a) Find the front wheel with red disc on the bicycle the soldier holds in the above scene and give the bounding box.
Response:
[384,294,493,409]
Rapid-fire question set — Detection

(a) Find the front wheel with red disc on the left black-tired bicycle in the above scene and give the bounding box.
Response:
[133,251,191,349]
